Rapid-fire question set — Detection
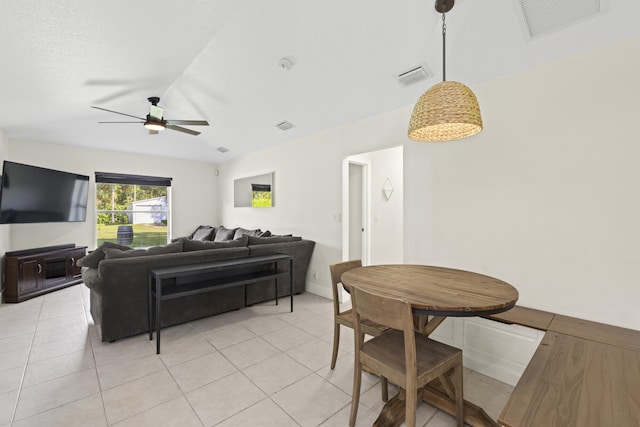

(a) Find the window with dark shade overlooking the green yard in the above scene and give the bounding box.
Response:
[96,172,171,248]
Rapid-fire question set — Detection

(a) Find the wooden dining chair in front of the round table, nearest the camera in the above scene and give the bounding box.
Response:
[349,287,464,427]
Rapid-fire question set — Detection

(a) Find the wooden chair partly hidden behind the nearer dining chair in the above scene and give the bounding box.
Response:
[329,259,389,402]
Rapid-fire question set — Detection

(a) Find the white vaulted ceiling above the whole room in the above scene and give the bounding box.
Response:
[0,0,640,163]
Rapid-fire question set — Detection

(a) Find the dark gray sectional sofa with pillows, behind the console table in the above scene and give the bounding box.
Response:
[77,226,315,341]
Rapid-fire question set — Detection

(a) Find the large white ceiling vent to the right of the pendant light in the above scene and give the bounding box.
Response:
[514,0,607,38]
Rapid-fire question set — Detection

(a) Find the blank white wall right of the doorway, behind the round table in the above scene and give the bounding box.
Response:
[405,37,640,329]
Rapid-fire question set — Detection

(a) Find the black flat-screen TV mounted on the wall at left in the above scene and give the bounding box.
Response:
[0,160,89,224]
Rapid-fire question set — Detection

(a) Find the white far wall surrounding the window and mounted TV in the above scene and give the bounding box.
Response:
[0,141,219,252]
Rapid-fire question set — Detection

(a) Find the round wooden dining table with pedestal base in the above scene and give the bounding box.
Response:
[342,264,518,426]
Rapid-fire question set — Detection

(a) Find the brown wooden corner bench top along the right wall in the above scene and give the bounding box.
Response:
[486,306,640,427]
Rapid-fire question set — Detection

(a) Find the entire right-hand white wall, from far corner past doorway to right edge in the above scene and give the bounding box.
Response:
[220,37,640,329]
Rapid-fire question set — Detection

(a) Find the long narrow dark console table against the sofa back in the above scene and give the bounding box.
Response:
[148,254,293,354]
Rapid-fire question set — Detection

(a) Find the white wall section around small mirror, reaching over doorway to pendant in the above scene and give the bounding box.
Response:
[220,118,406,297]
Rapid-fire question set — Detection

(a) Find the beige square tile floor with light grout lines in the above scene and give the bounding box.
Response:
[0,285,512,427]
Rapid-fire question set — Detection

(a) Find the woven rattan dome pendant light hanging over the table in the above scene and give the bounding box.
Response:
[409,0,482,142]
